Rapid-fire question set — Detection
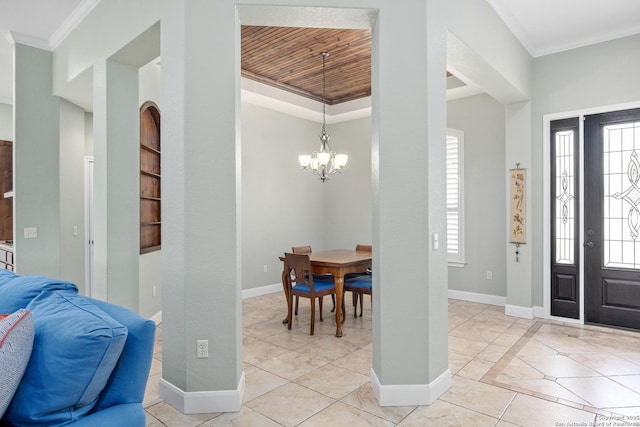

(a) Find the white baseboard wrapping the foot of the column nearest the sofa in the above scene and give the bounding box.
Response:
[160,372,244,414]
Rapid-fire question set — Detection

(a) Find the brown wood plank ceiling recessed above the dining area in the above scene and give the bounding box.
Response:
[241,26,371,105]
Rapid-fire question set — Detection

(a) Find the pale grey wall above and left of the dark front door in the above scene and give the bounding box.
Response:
[531,35,640,306]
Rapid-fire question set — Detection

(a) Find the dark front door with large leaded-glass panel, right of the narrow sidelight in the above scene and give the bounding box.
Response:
[584,109,640,329]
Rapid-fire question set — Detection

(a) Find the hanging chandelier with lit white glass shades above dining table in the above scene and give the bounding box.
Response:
[298,52,349,182]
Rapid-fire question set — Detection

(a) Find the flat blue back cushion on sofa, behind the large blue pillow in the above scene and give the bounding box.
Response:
[0,269,78,313]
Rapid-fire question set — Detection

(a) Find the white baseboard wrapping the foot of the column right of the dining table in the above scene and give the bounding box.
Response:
[371,368,451,406]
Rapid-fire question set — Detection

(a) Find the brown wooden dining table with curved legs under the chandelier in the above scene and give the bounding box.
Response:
[280,249,371,337]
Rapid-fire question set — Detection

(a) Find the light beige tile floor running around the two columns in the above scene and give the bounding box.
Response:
[144,294,640,427]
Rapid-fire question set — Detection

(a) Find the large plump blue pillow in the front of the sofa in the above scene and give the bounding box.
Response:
[6,290,127,427]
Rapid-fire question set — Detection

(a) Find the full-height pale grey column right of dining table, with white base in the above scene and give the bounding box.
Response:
[371,1,451,406]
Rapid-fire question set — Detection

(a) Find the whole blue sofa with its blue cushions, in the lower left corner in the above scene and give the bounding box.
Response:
[0,270,156,427]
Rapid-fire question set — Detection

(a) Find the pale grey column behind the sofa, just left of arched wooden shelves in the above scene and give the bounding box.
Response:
[92,60,140,311]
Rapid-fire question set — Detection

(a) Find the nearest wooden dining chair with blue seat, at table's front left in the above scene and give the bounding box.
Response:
[284,252,336,335]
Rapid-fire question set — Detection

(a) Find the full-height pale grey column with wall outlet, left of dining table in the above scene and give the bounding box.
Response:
[160,0,244,413]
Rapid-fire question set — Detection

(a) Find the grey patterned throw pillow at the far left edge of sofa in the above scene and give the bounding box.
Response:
[0,308,34,418]
